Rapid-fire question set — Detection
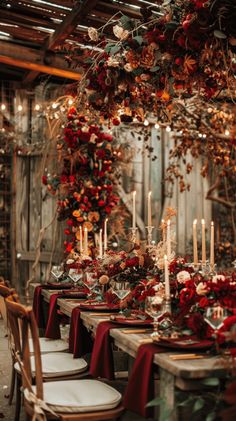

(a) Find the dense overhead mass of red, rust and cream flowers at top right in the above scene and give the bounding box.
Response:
[74,0,236,120]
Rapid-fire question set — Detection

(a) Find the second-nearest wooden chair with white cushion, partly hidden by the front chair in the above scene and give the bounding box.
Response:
[0,285,88,421]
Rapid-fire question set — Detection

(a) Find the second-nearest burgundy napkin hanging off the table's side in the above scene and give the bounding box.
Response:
[90,321,122,380]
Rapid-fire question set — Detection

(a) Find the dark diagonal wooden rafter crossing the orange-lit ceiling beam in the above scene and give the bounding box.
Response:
[23,0,97,85]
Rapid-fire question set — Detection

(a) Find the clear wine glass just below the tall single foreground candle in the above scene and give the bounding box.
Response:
[145,293,165,339]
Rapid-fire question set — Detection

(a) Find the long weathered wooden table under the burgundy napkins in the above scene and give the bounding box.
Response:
[32,284,229,421]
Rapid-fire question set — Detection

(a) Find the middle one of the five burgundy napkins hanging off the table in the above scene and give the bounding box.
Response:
[69,307,93,358]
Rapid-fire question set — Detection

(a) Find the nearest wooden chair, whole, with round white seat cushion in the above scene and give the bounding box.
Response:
[6,298,123,421]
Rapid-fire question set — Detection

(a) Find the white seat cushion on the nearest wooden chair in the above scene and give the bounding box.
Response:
[33,379,122,413]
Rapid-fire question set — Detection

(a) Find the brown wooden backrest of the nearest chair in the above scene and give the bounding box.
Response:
[5,295,43,399]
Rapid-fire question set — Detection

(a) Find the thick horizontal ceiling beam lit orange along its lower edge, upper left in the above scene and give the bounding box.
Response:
[0,41,81,80]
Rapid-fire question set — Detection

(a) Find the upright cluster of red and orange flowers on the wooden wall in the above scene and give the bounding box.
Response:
[42,107,119,253]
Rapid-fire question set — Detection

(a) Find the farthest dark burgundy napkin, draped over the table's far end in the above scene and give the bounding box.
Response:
[33,284,71,329]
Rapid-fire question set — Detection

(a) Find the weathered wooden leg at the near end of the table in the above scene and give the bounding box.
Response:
[159,367,178,421]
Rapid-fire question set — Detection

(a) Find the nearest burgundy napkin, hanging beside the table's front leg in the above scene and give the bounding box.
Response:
[123,343,166,417]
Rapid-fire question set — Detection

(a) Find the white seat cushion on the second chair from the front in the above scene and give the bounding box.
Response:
[14,352,88,378]
